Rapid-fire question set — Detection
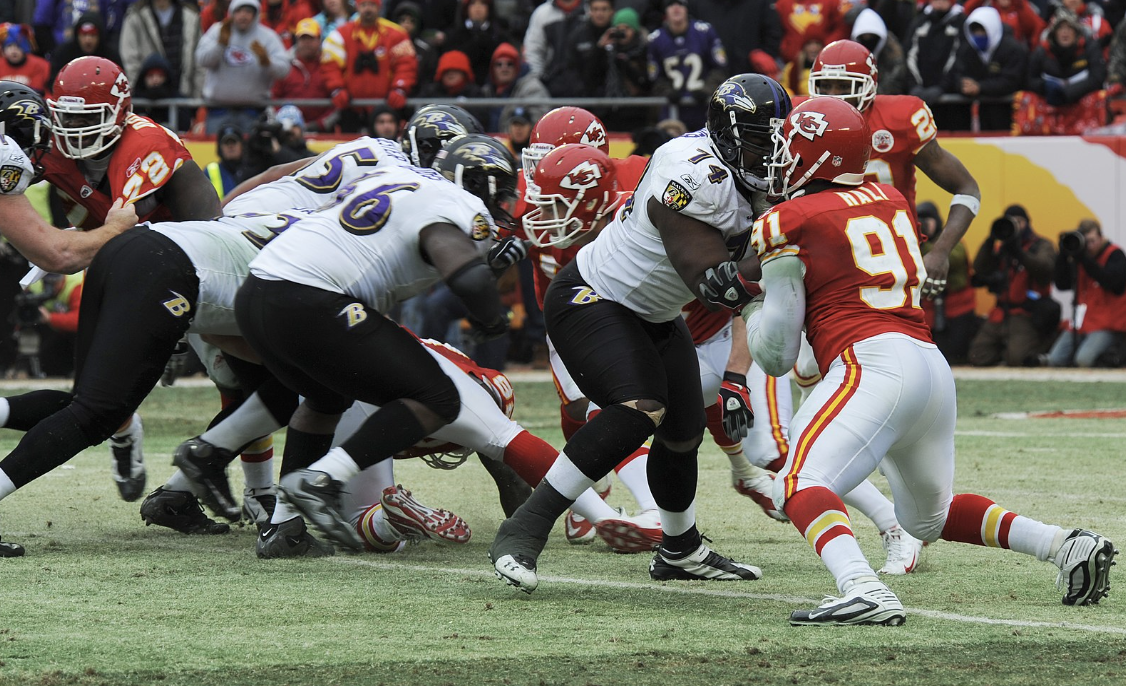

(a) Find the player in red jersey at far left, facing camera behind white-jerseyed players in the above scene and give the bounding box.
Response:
[21,56,221,501]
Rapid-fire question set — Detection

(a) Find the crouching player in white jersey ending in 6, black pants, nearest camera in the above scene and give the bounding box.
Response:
[235,135,516,550]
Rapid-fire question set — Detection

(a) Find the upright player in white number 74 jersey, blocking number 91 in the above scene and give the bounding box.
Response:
[489,74,790,593]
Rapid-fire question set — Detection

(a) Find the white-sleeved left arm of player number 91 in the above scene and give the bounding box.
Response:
[744,256,805,376]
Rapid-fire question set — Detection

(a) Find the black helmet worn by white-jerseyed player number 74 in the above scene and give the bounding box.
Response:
[707,74,790,191]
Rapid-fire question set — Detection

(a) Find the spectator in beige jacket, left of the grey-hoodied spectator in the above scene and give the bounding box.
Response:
[122,0,204,98]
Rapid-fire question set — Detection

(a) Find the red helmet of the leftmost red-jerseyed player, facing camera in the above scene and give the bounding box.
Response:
[47,56,133,160]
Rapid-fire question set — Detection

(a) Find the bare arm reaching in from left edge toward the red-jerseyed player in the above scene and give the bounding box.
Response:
[0,195,137,274]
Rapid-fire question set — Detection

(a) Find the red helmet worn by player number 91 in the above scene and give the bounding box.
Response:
[767,98,872,197]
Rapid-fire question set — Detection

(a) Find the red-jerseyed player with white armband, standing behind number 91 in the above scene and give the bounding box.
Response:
[810,41,981,299]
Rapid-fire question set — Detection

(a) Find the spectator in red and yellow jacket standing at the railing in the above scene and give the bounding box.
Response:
[321,0,419,132]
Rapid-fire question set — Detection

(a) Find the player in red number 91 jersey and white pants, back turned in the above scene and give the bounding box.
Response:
[743,98,1116,625]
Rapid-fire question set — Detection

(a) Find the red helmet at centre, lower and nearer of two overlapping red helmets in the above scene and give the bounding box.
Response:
[524,143,622,248]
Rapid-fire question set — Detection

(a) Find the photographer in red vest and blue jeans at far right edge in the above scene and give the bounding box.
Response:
[1048,220,1126,367]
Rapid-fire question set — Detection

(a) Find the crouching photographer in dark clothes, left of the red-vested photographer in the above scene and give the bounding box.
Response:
[969,205,1060,367]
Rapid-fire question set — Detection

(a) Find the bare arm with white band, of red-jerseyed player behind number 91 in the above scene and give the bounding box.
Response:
[915,139,981,297]
